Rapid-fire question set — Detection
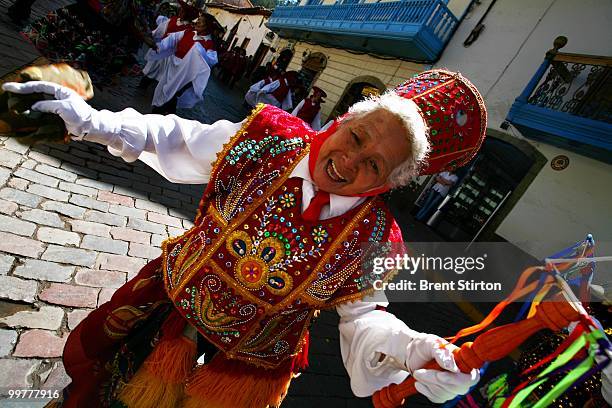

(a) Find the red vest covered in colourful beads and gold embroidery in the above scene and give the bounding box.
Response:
[162,105,401,368]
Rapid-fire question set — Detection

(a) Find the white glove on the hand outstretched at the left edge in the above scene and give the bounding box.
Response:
[2,81,121,144]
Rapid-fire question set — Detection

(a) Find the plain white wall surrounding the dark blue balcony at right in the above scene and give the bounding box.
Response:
[436,0,612,257]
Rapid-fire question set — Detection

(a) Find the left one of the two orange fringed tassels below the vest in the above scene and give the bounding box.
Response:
[119,336,196,408]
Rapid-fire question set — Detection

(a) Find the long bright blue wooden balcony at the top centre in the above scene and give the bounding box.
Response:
[268,0,458,62]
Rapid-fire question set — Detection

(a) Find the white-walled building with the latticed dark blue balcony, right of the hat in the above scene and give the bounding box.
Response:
[435,0,612,258]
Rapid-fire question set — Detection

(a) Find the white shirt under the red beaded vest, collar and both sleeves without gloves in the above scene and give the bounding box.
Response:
[84,108,436,397]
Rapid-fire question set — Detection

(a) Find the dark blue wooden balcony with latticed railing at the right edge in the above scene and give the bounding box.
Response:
[506,37,612,163]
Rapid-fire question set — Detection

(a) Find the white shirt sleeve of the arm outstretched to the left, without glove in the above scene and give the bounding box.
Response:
[84,108,242,184]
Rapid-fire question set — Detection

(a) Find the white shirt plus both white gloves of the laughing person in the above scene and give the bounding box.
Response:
[5,82,478,402]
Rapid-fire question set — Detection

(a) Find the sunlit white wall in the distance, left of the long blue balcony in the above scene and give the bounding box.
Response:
[208,6,270,56]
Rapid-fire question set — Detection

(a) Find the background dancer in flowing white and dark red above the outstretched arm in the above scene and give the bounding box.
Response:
[148,14,220,114]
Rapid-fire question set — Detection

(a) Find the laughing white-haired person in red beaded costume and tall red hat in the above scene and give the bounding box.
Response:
[4,70,486,408]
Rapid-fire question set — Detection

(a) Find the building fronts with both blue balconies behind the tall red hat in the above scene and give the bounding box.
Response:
[269,0,612,258]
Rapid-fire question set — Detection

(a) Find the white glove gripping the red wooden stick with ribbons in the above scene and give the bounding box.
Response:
[406,335,480,404]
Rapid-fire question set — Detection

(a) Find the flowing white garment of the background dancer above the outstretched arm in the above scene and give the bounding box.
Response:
[147,31,218,108]
